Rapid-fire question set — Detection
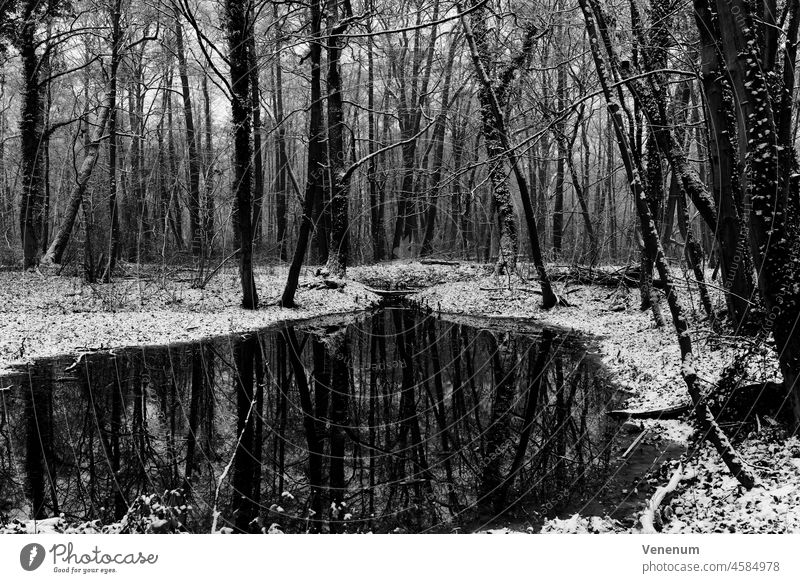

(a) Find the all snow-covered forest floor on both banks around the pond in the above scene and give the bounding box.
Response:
[0,262,800,532]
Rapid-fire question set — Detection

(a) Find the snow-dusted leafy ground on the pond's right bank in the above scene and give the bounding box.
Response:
[396,266,800,533]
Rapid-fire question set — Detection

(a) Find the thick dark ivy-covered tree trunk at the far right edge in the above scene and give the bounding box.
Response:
[716,0,800,425]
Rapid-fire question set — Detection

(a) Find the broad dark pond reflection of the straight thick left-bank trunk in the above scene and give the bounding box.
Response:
[232,334,260,532]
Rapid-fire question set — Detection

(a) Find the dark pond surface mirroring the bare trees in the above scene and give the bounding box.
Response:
[0,310,620,532]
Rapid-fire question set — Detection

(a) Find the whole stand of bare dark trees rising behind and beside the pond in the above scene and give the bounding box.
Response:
[0,0,800,460]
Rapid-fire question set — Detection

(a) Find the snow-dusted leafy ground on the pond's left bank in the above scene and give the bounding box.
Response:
[0,265,379,372]
